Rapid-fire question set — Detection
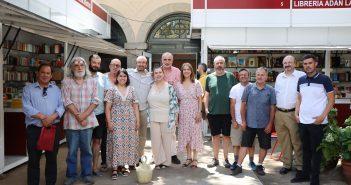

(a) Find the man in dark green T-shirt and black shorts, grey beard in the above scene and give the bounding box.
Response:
[205,56,236,168]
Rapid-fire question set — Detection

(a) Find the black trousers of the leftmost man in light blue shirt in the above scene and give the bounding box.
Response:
[27,125,59,185]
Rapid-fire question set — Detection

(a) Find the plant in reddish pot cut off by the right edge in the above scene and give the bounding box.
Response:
[340,116,351,184]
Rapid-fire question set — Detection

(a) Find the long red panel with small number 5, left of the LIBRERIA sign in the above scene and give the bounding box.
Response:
[193,0,290,9]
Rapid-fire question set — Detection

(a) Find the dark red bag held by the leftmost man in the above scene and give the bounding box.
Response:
[37,125,56,152]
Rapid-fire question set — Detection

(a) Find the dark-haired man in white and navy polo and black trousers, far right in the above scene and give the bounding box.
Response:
[291,55,335,185]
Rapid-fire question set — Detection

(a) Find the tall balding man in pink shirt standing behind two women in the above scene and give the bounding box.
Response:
[162,52,180,164]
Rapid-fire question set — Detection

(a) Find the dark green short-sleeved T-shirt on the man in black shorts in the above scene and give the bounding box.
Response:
[205,72,237,115]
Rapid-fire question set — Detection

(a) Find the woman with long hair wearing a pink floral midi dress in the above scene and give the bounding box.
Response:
[175,63,203,168]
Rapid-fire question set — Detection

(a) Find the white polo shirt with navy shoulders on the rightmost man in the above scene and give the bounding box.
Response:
[297,73,334,124]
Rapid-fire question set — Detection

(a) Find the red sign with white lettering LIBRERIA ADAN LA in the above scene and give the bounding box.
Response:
[293,0,351,9]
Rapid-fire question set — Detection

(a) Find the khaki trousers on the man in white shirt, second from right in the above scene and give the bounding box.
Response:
[274,110,302,170]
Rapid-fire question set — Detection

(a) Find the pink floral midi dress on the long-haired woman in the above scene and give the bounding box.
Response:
[175,81,203,152]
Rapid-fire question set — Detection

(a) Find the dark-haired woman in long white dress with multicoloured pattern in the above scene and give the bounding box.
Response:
[105,69,139,180]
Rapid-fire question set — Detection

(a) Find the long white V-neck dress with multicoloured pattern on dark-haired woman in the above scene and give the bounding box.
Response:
[105,86,139,168]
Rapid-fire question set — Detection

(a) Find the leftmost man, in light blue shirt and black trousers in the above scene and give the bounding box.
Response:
[22,64,65,185]
